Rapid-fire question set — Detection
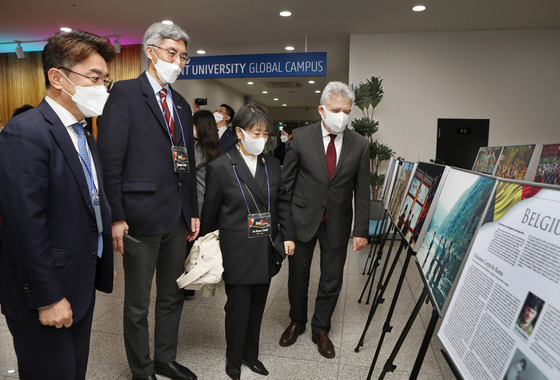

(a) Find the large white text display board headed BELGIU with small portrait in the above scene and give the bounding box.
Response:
[438,180,560,380]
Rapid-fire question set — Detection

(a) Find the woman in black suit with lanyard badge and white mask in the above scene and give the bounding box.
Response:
[201,104,295,379]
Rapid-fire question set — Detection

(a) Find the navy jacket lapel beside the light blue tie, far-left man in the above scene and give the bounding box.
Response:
[37,100,94,214]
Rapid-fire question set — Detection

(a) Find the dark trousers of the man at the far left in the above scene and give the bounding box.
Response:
[6,297,95,380]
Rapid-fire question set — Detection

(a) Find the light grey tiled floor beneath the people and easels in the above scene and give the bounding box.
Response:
[0,239,455,380]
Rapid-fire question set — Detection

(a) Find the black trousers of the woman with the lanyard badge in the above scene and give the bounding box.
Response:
[225,284,270,368]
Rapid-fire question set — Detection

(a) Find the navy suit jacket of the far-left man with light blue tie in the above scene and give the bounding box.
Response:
[0,100,113,326]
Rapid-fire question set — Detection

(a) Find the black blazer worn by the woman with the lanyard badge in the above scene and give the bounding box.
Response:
[201,147,295,285]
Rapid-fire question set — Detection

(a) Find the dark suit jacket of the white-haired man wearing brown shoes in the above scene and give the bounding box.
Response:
[282,122,370,247]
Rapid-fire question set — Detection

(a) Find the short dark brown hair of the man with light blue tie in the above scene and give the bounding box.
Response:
[42,30,115,88]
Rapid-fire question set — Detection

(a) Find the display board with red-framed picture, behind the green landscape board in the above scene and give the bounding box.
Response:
[396,162,449,251]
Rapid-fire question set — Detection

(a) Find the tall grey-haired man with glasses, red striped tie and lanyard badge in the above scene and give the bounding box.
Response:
[98,23,200,379]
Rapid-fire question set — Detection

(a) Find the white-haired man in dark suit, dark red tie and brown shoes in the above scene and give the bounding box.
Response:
[280,82,370,358]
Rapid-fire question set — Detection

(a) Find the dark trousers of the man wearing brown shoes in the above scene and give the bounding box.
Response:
[288,222,347,332]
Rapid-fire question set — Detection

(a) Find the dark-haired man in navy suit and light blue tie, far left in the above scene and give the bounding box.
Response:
[0,31,114,380]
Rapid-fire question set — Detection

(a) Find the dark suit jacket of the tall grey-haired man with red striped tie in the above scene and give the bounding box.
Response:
[97,72,198,235]
